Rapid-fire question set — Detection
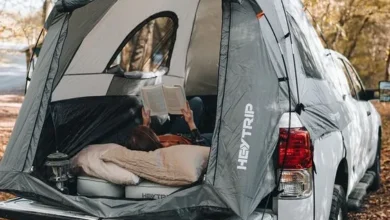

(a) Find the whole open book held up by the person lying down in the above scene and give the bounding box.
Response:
[141,84,186,116]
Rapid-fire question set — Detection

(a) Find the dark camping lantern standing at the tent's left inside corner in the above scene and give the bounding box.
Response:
[45,152,71,193]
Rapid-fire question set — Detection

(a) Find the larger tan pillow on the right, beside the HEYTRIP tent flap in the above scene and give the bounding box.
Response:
[101,145,210,186]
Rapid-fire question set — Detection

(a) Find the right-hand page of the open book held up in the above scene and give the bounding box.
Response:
[163,86,186,115]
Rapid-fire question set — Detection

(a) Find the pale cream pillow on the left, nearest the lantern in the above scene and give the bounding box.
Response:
[71,144,140,185]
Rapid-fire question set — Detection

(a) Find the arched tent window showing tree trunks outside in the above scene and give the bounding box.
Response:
[109,17,177,72]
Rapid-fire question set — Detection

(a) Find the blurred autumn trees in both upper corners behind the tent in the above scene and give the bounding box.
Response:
[0,0,390,88]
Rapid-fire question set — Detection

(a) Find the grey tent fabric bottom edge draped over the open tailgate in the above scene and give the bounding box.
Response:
[0,171,231,219]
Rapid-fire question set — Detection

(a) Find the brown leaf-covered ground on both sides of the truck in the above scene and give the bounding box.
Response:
[0,95,390,220]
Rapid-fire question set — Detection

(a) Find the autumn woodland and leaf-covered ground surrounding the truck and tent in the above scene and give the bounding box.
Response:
[0,0,390,220]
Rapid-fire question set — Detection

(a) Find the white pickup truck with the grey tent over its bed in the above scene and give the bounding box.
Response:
[0,51,382,220]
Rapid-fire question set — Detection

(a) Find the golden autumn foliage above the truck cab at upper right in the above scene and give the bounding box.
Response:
[304,0,390,88]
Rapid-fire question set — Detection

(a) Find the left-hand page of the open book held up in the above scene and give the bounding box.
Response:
[141,85,168,116]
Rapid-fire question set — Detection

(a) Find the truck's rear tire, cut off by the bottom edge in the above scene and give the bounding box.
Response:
[329,185,348,220]
